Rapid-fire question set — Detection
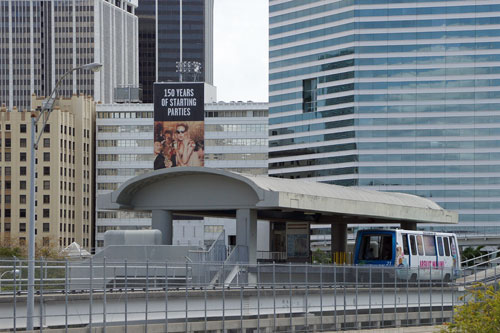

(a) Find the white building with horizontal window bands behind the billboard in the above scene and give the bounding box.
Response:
[95,97,268,249]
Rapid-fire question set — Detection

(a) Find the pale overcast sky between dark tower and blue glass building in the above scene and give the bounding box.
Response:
[214,0,269,102]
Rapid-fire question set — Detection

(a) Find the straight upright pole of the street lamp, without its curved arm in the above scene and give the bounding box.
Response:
[26,113,36,331]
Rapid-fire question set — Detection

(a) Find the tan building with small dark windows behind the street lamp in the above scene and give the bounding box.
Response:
[0,95,95,249]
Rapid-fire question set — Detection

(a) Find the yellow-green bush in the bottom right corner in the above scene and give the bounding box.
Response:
[442,284,500,333]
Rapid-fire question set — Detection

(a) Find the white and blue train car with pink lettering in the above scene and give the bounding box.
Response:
[354,229,460,281]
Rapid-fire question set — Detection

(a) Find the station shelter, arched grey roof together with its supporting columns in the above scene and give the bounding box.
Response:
[98,167,458,263]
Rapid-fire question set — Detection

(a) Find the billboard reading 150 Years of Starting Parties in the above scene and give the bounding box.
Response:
[154,82,205,170]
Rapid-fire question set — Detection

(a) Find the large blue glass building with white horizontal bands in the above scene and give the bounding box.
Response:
[269,0,500,233]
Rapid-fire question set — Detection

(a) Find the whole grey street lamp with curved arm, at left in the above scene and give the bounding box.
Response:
[26,62,102,331]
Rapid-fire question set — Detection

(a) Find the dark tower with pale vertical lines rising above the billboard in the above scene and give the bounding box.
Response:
[136,0,214,103]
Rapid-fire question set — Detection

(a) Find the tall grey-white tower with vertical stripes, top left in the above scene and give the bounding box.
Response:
[0,0,139,110]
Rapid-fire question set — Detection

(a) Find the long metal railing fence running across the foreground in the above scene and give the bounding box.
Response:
[0,260,500,332]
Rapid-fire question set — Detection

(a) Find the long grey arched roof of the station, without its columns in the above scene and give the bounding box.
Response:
[98,167,458,223]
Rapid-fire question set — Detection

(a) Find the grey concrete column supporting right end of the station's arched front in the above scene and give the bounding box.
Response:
[236,209,257,264]
